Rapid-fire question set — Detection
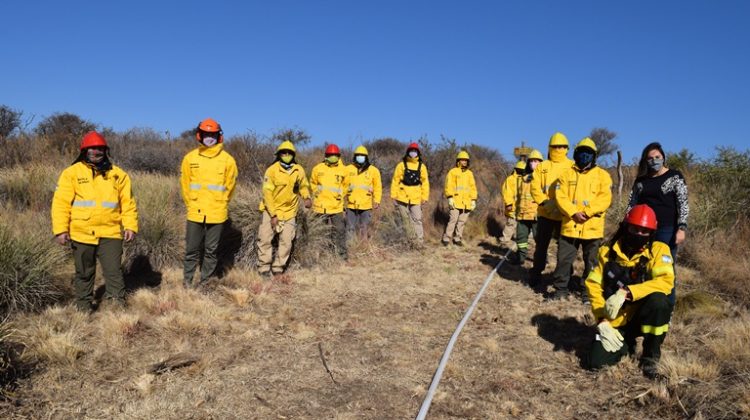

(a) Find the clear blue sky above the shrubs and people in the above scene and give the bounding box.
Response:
[0,0,750,160]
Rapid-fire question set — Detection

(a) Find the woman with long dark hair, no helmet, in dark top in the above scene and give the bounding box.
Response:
[626,142,690,304]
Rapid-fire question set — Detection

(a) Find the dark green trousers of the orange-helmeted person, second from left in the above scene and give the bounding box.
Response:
[183,220,224,287]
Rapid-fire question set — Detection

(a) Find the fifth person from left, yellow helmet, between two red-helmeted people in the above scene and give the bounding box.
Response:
[346,146,383,238]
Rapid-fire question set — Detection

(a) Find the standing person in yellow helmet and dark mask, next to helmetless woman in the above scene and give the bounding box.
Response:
[552,137,612,303]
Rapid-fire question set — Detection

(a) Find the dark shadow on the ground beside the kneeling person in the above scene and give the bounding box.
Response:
[531,314,593,367]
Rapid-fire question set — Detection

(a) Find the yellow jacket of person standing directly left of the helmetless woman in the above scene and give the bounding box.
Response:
[555,166,612,239]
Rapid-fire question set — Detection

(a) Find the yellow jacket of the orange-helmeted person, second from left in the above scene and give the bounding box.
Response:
[180,143,237,223]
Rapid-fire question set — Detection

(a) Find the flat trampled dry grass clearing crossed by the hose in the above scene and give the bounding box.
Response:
[0,235,750,419]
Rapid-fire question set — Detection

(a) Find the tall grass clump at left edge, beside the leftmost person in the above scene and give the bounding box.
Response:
[0,212,66,314]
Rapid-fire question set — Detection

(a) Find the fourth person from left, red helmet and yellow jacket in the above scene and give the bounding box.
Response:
[310,144,349,260]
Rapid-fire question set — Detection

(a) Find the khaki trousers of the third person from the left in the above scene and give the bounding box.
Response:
[256,211,297,274]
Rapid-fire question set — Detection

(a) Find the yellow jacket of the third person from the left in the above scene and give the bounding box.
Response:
[259,162,310,221]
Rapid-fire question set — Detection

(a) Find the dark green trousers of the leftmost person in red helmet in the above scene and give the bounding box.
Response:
[70,238,125,311]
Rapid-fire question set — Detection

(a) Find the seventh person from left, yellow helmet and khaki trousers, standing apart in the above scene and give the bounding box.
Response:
[441,150,477,246]
